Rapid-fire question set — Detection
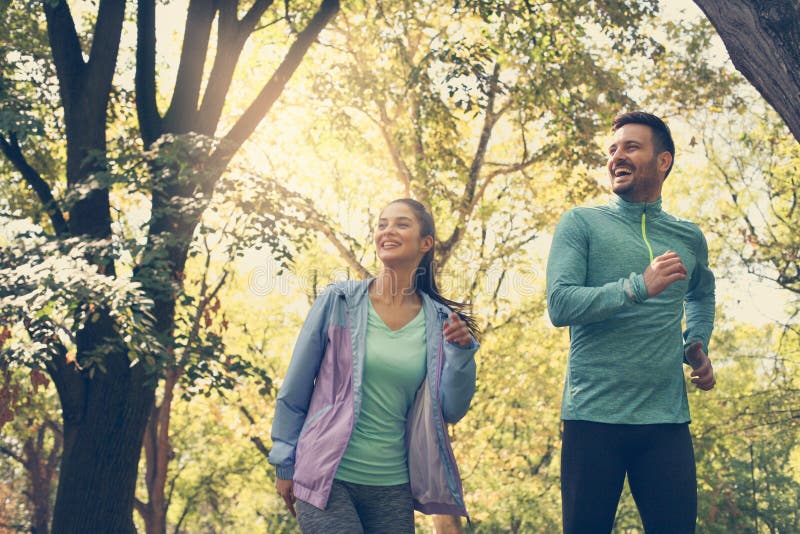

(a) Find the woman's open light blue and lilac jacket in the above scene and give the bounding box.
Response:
[269,280,478,516]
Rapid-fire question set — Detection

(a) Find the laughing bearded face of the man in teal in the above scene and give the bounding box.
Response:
[607,124,672,202]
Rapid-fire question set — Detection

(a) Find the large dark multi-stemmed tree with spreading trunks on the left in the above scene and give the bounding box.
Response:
[0,0,339,532]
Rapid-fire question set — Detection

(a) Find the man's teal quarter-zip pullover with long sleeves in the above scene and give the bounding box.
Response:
[547,197,714,424]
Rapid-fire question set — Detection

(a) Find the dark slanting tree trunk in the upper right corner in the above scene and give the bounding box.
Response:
[695,0,800,141]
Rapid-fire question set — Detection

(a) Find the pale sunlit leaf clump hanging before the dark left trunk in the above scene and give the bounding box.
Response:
[0,219,163,374]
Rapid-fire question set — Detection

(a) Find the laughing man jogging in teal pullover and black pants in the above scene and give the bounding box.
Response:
[547,112,715,534]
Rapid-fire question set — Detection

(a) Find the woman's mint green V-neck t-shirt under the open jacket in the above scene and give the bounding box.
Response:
[336,302,426,486]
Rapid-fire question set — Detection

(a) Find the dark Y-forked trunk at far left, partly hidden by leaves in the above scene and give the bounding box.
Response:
[42,0,148,534]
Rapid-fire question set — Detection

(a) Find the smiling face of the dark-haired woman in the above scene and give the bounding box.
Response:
[375,202,433,268]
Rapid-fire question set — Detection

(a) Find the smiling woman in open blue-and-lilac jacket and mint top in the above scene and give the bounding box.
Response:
[269,199,478,534]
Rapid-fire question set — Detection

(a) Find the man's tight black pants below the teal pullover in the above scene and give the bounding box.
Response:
[561,421,697,534]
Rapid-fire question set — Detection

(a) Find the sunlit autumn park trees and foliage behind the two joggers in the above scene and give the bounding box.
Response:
[0,0,800,533]
